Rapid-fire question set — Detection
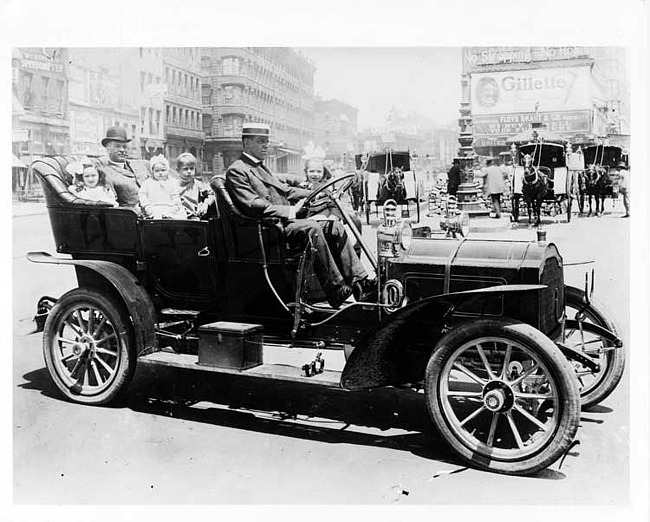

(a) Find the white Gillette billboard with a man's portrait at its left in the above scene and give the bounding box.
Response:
[471,66,591,116]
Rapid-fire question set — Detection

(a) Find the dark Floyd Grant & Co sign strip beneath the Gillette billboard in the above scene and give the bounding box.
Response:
[473,110,591,139]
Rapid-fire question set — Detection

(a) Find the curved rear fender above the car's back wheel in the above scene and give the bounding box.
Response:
[27,252,157,356]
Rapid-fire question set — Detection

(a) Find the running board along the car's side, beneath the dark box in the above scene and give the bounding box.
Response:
[138,352,341,388]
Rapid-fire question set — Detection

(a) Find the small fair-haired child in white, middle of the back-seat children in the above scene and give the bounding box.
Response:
[139,155,187,219]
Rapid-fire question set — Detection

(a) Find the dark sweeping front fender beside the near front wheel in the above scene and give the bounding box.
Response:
[341,285,545,390]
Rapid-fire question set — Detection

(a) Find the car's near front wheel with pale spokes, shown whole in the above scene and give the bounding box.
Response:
[425,320,580,475]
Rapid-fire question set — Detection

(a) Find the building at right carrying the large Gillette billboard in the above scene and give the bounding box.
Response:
[463,47,629,156]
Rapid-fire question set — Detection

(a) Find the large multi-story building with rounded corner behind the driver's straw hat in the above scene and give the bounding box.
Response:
[202,47,315,173]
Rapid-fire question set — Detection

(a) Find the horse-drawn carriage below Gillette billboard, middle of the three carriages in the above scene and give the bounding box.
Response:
[512,140,570,225]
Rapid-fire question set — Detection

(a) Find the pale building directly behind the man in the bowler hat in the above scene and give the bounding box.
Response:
[67,48,140,158]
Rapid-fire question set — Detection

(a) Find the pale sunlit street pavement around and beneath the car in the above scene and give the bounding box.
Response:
[12,201,645,508]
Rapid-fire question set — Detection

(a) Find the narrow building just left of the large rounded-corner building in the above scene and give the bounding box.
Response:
[162,47,204,172]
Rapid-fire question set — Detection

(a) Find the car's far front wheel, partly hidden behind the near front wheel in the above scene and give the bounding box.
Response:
[564,286,625,409]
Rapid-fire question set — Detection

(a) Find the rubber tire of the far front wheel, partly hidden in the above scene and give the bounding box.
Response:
[564,286,625,410]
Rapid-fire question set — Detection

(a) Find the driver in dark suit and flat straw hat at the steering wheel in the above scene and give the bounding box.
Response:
[226,123,376,308]
